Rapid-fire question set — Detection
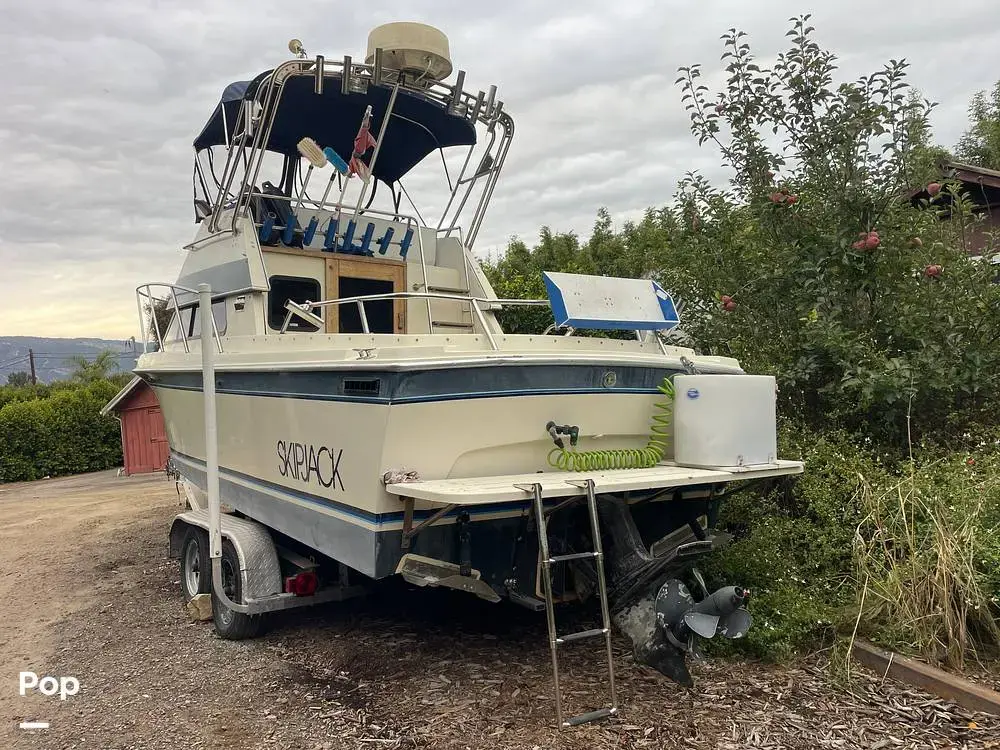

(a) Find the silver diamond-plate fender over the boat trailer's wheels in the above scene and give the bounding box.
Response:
[170,510,282,600]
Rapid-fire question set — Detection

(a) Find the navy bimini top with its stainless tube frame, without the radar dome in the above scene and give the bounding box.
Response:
[194,50,514,253]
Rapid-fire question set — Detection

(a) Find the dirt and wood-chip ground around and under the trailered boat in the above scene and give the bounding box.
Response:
[0,472,1000,750]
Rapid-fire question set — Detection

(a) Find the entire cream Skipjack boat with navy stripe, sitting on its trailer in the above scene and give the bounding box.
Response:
[135,23,803,726]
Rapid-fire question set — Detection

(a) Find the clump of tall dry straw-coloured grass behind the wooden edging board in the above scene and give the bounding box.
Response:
[854,455,1000,668]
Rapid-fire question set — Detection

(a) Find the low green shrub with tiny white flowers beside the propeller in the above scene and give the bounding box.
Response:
[706,423,883,659]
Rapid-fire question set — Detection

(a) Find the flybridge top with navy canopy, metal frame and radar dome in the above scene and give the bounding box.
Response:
[194,24,513,254]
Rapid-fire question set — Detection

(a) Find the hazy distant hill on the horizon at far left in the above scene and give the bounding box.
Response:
[0,336,142,385]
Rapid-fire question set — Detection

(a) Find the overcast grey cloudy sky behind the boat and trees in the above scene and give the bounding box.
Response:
[0,0,1000,338]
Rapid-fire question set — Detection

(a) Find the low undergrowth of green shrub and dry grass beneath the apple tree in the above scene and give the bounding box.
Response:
[704,423,1000,668]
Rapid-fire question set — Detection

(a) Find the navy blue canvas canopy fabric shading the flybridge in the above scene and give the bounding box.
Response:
[194,71,476,184]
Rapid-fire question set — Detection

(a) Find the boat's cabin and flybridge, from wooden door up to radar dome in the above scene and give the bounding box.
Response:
[146,24,513,348]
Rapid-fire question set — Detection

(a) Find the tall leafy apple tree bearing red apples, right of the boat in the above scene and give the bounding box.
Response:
[662,16,1000,450]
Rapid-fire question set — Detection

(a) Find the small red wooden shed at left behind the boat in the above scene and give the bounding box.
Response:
[101,378,170,476]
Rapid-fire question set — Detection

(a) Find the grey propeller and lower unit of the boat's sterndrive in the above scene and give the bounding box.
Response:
[637,569,752,687]
